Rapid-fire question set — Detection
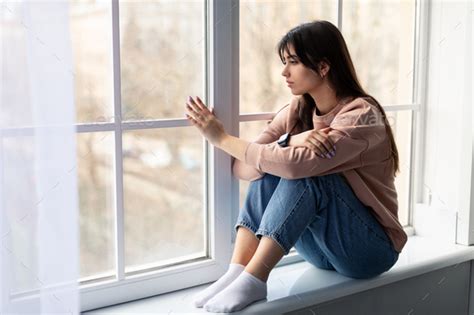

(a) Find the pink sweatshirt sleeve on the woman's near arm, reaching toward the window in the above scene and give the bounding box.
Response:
[245,102,386,179]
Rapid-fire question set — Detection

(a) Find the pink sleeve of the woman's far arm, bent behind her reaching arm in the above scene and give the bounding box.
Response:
[232,104,290,181]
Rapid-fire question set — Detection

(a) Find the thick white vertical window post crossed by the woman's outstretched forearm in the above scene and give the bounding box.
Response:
[209,0,239,263]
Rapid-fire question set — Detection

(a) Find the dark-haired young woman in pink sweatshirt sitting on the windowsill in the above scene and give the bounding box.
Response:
[186,21,407,312]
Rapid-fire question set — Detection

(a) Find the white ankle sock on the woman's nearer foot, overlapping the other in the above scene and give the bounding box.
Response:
[204,270,267,313]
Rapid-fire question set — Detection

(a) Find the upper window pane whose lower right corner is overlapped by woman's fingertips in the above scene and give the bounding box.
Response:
[120,0,205,120]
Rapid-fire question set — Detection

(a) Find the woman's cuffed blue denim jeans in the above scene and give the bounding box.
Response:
[234,173,398,279]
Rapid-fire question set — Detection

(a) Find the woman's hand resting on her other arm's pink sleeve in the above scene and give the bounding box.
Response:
[288,129,336,158]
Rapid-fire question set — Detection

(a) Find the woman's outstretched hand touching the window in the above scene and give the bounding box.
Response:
[185,96,226,146]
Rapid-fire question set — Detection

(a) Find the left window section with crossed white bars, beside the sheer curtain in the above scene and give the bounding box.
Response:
[74,0,210,309]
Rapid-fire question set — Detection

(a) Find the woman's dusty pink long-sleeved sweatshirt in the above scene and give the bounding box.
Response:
[232,96,407,252]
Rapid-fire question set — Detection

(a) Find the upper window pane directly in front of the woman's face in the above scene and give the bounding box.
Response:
[239,0,337,113]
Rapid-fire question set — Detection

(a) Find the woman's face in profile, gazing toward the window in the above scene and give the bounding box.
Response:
[281,45,323,95]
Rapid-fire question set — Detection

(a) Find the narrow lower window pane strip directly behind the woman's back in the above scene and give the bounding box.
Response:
[386,110,413,225]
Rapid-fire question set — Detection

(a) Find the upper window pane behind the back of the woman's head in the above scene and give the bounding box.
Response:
[342,0,415,105]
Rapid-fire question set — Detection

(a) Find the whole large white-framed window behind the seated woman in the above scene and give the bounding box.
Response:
[78,0,418,311]
